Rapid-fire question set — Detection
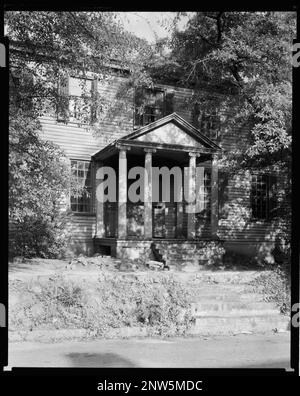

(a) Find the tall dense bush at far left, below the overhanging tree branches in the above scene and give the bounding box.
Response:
[9,111,82,258]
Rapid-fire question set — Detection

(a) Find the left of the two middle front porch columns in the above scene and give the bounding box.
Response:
[144,148,156,239]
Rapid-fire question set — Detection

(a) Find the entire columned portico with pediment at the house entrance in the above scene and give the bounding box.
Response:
[93,113,220,262]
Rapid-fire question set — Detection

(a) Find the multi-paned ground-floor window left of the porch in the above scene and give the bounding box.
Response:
[71,160,93,213]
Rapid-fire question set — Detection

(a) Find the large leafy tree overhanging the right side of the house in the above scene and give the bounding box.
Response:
[149,11,296,268]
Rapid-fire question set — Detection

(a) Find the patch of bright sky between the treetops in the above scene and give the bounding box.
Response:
[118,11,192,43]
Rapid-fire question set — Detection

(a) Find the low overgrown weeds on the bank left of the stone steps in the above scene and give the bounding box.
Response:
[10,274,192,336]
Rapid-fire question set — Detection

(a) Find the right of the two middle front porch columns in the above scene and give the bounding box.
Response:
[187,152,200,239]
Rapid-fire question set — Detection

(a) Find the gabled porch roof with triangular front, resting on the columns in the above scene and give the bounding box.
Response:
[92,113,221,160]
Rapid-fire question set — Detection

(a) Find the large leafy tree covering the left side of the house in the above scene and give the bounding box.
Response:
[5,12,150,256]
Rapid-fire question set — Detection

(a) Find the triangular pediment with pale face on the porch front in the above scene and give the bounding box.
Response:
[123,113,220,150]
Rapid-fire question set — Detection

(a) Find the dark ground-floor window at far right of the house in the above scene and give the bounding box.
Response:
[251,175,277,220]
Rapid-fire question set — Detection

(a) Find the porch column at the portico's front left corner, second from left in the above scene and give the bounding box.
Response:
[118,146,129,239]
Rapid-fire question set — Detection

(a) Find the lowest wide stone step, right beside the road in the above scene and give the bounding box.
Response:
[188,315,289,335]
